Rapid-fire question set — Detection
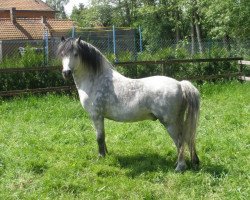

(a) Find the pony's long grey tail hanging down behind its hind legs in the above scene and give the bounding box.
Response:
[181,81,200,151]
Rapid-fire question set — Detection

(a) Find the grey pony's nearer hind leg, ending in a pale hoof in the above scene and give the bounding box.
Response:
[167,124,187,172]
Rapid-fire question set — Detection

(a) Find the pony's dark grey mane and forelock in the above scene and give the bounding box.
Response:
[57,38,103,73]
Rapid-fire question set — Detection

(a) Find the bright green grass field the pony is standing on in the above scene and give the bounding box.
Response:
[0,82,250,200]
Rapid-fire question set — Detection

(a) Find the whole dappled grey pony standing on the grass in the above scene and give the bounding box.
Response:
[58,38,200,171]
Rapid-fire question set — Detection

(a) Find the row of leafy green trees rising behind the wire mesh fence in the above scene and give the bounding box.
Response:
[69,0,250,40]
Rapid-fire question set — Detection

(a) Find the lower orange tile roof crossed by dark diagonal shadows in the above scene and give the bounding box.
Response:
[0,18,73,40]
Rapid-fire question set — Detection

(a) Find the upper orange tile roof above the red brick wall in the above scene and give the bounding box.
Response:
[0,0,54,11]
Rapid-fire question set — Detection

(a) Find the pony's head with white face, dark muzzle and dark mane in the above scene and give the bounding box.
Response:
[57,37,102,78]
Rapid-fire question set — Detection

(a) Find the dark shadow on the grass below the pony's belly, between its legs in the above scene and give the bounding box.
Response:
[117,153,176,177]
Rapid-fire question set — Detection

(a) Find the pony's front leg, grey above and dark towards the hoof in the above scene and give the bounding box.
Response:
[93,117,108,157]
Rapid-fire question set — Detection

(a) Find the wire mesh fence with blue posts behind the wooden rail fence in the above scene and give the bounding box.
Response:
[0,27,250,68]
